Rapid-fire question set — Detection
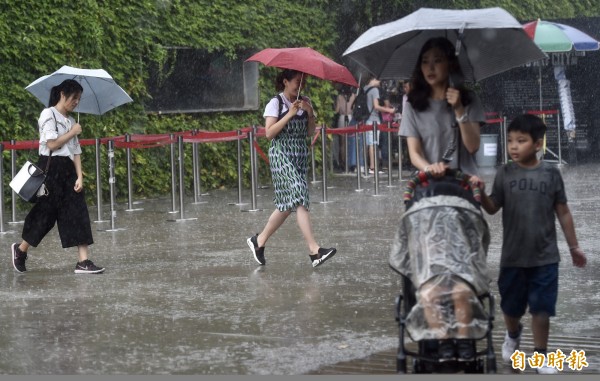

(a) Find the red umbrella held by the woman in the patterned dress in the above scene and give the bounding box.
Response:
[246,48,358,87]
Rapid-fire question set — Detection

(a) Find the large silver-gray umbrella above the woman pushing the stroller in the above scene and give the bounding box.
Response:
[343,8,546,82]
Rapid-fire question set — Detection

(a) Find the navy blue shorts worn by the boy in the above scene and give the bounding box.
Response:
[498,263,558,317]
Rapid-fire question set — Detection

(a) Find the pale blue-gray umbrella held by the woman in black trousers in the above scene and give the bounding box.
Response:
[25,65,133,115]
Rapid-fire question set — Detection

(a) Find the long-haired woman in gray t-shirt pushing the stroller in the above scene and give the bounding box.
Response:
[400,37,485,176]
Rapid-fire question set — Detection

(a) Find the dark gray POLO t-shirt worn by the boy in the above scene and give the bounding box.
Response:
[490,161,567,267]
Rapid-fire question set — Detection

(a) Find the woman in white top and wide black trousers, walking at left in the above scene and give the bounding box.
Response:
[11,79,104,274]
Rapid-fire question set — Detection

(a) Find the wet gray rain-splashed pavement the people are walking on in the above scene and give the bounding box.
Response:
[0,164,600,375]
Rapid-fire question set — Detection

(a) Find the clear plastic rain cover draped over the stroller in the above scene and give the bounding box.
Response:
[389,195,490,341]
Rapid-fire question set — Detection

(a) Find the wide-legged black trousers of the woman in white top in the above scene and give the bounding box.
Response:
[22,156,94,248]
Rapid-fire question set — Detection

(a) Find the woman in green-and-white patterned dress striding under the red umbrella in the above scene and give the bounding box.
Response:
[247,69,336,267]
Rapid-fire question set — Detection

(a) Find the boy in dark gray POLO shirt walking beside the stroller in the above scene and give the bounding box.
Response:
[474,114,587,374]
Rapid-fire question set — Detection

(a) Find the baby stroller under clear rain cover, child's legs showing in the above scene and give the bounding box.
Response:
[389,170,496,373]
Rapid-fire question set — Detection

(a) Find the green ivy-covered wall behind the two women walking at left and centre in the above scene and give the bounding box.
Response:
[0,0,337,203]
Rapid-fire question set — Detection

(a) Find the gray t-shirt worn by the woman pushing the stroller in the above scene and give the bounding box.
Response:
[400,93,485,175]
